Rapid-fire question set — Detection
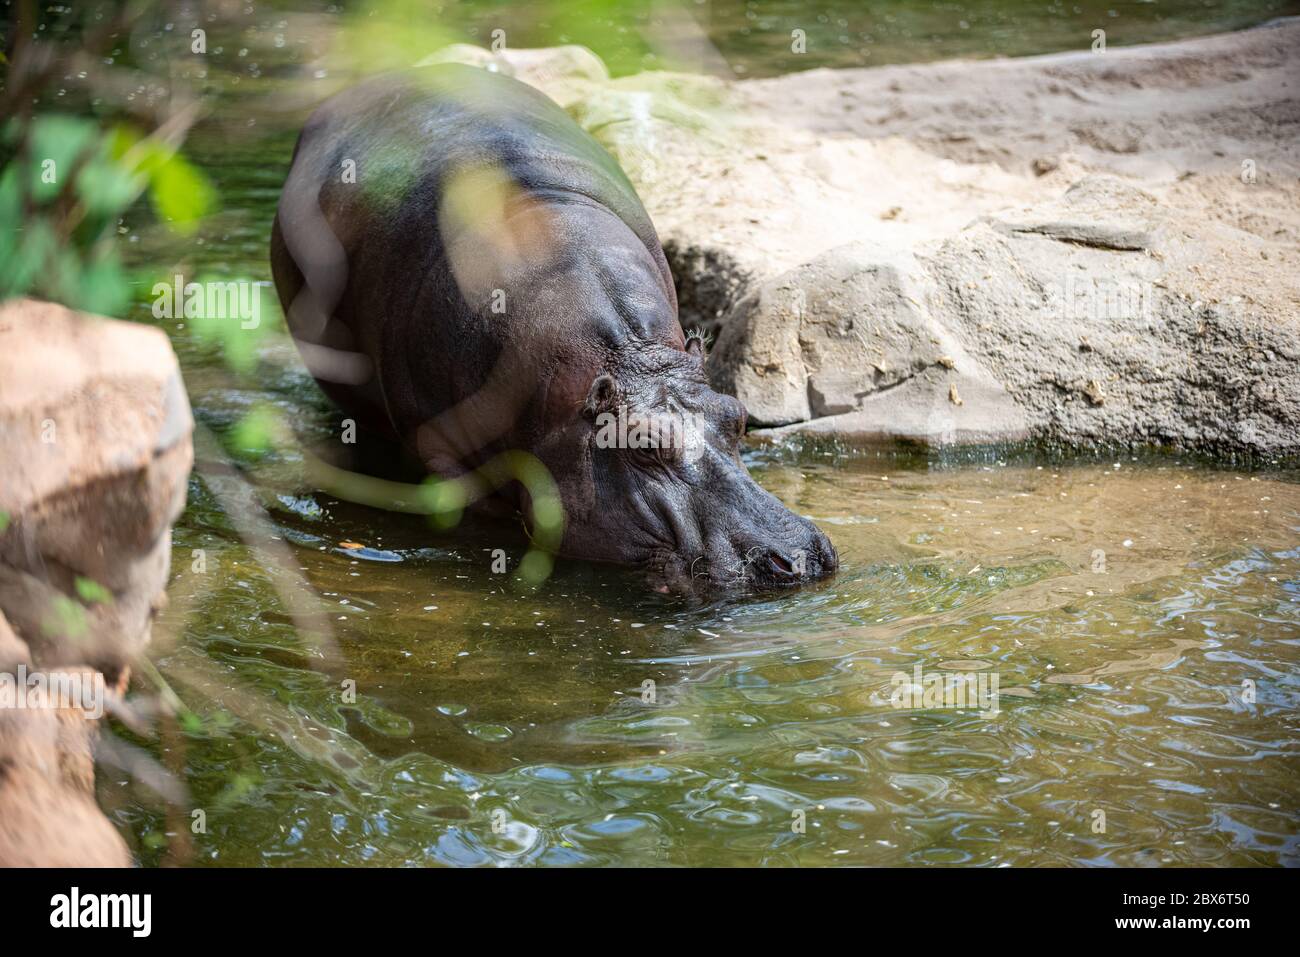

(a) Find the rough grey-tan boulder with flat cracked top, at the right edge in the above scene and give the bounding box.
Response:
[927,177,1300,455]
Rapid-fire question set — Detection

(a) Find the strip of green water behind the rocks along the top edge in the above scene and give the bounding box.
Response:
[178,0,1300,77]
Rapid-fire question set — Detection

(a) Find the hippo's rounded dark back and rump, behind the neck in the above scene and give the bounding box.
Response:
[272,65,680,452]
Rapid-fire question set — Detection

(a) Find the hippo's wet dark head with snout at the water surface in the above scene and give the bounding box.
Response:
[533,339,839,593]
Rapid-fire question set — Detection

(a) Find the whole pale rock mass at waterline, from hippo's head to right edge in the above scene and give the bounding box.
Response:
[710,176,1300,455]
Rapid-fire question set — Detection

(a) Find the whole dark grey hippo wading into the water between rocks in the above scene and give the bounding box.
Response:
[272,65,839,593]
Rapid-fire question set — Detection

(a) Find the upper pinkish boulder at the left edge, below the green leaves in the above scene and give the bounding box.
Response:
[0,300,194,681]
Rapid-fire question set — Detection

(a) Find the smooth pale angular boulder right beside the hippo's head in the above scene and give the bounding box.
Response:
[709,242,1026,442]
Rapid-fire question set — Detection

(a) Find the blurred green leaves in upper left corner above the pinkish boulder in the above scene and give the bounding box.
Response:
[0,4,216,316]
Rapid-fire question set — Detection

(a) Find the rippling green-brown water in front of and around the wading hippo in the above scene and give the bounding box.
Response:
[99,3,1300,866]
